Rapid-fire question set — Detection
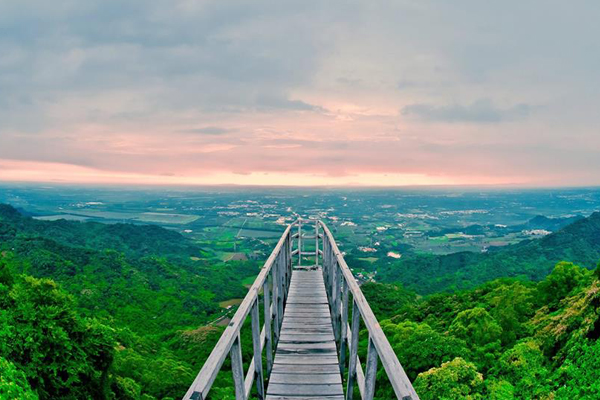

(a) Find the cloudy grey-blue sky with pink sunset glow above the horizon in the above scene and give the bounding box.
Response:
[0,0,600,186]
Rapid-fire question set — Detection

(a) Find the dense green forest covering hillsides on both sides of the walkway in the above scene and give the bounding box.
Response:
[0,206,600,400]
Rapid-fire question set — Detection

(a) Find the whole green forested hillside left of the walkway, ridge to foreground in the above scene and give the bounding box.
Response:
[0,206,258,400]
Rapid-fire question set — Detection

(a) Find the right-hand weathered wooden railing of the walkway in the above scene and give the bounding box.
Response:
[318,221,419,400]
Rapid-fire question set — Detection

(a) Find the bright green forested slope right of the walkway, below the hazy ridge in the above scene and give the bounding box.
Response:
[361,262,600,400]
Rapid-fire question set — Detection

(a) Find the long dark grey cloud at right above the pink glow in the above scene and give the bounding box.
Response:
[402,99,531,123]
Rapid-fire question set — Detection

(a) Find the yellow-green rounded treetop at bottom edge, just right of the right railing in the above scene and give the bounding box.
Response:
[414,357,485,400]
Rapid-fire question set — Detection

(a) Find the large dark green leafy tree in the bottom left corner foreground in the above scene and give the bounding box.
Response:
[0,262,114,398]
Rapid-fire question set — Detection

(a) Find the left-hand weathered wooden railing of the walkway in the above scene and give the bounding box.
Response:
[183,223,296,400]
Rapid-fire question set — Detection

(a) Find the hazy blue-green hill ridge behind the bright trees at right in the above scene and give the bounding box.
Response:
[377,212,600,294]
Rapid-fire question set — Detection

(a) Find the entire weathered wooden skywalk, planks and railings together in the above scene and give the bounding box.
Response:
[183,219,419,400]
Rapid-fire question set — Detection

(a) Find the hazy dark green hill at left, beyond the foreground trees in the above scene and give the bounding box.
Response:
[0,205,258,332]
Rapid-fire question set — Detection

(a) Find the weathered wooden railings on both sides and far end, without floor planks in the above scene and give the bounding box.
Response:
[183,219,419,400]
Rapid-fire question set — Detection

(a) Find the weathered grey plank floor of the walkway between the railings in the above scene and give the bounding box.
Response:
[267,269,344,400]
